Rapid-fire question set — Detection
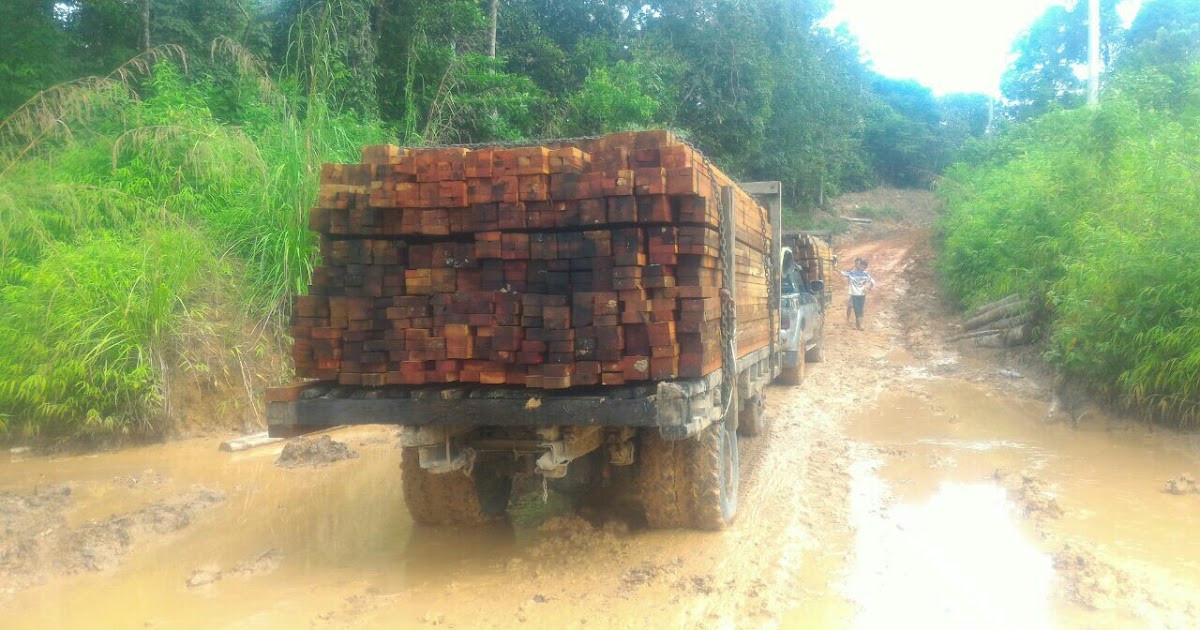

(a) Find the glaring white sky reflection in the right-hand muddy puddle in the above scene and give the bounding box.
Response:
[845,456,1051,628]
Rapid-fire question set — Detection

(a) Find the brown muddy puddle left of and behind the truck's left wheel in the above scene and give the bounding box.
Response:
[0,427,552,628]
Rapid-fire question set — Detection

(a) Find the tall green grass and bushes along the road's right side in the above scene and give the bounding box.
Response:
[938,74,1200,424]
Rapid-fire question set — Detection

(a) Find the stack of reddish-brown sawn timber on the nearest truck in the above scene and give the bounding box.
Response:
[292,131,772,389]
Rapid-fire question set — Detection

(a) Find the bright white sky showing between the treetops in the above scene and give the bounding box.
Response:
[826,0,1141,96]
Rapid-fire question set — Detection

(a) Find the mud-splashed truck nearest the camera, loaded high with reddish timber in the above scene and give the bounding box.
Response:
[266,132,828,529]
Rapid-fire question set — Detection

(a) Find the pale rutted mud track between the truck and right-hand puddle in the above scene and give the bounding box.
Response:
[672,228,928,626]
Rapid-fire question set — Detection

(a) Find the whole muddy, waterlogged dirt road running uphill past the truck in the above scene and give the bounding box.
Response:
[0,189,1200,628]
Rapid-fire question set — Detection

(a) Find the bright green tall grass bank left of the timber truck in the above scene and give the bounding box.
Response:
[0,34,385,436]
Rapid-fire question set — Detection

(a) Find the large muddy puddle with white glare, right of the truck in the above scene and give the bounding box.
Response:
[835,380,1200,628]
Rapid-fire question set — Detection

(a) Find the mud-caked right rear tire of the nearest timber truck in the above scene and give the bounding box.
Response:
[637,422,739,529]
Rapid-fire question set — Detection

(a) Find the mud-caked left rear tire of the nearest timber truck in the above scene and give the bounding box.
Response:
[400,448,512,524]
